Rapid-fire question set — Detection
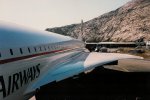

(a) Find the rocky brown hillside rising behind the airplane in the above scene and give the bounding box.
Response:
[46,0,150,42]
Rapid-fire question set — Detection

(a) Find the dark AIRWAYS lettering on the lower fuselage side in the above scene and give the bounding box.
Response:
[0,64,40,98]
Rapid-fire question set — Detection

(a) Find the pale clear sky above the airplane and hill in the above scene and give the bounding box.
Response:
[0,0,131,30]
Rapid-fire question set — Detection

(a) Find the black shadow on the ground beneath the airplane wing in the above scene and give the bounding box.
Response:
[36,67,150,100]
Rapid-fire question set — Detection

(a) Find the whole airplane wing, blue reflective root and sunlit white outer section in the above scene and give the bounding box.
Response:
[26,52,143,93]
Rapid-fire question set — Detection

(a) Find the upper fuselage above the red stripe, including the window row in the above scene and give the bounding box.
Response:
[0,23,84,60]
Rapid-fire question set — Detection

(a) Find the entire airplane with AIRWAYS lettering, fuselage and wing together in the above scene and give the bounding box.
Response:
[0,22,143,100]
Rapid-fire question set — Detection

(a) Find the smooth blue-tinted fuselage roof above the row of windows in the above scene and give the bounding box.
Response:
[0,23,73,48]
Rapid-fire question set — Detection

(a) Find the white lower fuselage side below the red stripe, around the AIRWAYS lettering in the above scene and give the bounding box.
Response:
[0,51,83,100]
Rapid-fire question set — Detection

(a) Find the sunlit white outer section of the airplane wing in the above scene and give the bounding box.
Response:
[84,52,143,70]
